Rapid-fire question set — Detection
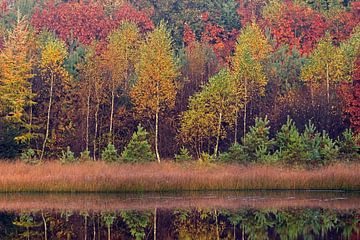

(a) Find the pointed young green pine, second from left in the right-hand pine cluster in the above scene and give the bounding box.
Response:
[275,116,304,163]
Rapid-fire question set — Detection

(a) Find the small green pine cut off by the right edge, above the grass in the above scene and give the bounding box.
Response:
[337,129,360,159]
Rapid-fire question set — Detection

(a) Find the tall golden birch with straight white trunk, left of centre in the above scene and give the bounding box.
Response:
[131,23,178,162]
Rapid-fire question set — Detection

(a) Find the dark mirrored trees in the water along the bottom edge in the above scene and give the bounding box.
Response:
[0,208,360,240]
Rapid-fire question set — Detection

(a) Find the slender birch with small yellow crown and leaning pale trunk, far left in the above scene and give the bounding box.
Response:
[40,39,70,160]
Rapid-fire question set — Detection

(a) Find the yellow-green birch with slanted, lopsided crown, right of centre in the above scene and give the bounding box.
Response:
[180,69,235,155]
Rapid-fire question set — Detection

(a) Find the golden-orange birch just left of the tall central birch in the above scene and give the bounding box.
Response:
[102,23,140,142]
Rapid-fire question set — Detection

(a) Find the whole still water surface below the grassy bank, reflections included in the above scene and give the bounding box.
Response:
[0,191,360,240]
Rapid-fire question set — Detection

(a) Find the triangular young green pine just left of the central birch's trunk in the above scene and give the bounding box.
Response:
[121,125,155,162]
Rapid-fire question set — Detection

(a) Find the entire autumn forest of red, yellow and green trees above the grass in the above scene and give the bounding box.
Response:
[0,0,360,165]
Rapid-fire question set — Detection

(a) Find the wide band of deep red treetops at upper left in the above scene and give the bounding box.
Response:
[31,1,154,44]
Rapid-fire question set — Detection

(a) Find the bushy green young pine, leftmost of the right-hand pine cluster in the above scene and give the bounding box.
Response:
[243,117,273,162]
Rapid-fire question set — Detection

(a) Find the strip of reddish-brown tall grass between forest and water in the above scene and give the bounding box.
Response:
[0,162,360,192]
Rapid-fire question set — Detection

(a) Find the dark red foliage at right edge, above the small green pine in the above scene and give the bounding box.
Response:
[340,57,360,134]
